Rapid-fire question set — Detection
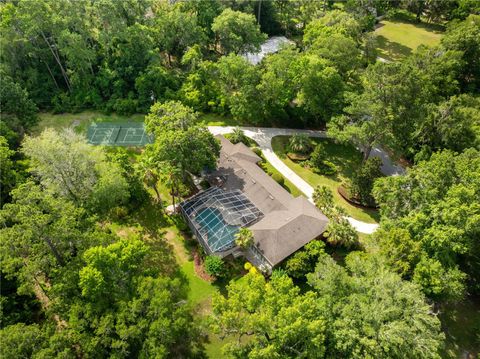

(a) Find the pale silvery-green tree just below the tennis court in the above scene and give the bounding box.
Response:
[23,129,129,212]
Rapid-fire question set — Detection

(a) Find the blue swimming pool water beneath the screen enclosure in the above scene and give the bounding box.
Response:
[195,207,239,252]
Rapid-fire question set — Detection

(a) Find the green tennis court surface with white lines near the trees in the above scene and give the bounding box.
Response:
[87,122,153,146]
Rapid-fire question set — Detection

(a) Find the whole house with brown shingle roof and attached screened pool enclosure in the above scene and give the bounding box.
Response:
[180,136,328,273]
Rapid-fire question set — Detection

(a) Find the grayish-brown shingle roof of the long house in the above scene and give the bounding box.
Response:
[214,136,328,266]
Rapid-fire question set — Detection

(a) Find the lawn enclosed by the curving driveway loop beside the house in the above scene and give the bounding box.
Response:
[272,136,380,223]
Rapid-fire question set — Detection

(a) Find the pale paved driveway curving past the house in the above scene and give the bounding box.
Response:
[208,126,403,234]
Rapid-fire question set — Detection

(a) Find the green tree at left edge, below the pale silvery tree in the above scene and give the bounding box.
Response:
[0,182,90,292]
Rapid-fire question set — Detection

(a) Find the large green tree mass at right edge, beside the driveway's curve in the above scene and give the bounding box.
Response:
[373,149,480,299]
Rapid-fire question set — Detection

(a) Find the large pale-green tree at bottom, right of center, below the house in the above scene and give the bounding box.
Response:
[308,253,444,358]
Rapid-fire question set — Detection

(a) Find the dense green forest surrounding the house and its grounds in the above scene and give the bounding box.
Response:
[0,0,480,358]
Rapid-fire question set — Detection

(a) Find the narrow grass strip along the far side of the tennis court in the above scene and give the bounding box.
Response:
[33,111,145,134]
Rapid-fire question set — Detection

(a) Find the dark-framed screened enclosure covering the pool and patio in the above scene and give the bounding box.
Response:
[180,187,263,254]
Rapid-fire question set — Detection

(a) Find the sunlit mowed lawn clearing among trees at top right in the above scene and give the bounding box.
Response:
[375,20,442,61]
